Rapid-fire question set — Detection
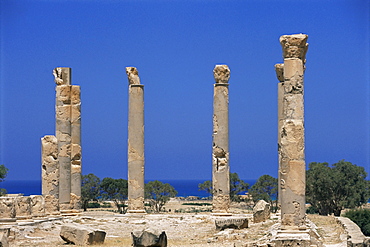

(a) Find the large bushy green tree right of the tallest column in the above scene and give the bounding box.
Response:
[306,160,369,216]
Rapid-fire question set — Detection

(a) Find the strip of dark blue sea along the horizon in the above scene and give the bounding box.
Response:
[0,179,256,198]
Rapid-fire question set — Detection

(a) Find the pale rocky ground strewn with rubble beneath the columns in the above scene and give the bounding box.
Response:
[4,202,346,247]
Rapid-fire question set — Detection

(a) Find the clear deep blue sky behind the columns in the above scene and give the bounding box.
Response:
[0,0,370,180]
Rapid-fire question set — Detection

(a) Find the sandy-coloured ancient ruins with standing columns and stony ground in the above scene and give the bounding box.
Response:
[0,34,370,247]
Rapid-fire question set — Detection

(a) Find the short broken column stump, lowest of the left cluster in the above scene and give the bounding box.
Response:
[41,135,59,213]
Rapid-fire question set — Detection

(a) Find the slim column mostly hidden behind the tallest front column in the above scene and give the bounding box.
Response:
[275,63,284,208]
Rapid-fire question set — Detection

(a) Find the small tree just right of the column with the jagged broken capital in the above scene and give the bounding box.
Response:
[145,180,177,212]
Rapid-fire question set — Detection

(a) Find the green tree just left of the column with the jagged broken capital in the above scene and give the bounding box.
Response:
[100,178,128,213]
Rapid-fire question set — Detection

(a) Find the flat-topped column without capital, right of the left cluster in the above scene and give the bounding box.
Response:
[71,85,82,209]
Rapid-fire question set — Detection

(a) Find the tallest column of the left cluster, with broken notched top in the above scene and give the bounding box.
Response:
[53,67,71,210]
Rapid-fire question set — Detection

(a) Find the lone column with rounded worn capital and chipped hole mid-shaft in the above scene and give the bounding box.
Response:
[212,65,230,215]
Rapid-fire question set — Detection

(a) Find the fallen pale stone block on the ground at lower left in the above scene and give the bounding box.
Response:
[60,224,106,245]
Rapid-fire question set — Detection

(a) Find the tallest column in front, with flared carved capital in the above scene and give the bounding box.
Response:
[279,34,308,230]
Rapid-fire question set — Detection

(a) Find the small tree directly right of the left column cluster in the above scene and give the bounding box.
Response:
[81,173,100,211]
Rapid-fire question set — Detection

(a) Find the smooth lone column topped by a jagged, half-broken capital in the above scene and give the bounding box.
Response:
[126,67,145,213]
